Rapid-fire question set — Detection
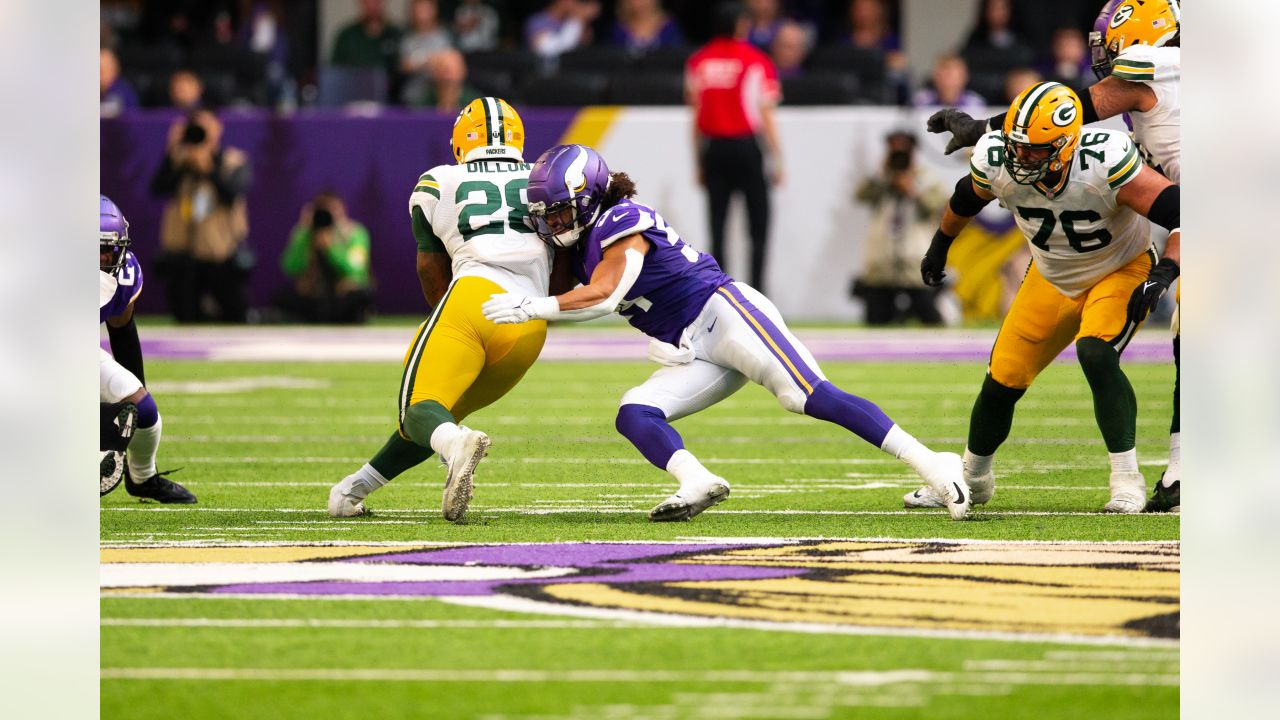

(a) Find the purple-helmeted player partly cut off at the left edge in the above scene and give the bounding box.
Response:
[97,195,196,503]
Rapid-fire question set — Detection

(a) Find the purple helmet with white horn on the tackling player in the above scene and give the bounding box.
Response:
[529,145,609,247]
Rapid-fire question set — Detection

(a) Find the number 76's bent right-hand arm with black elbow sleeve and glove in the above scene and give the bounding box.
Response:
[1116,165,1183,323]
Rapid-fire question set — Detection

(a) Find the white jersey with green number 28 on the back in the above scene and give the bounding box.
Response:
[408,160,552,297]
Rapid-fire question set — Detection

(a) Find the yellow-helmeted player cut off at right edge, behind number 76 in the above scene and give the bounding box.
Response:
[926,0,1181,512]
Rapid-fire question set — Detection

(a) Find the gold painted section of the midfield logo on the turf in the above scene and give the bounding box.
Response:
[543,542,1180,637]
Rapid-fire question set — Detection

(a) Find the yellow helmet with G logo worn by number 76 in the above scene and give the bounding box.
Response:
[1004,82,1083,184]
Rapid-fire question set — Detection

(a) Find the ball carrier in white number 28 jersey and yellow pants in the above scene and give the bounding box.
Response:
[329,97,552,520]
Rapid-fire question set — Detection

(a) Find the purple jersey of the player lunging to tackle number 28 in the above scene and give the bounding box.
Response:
[575,200,733,345]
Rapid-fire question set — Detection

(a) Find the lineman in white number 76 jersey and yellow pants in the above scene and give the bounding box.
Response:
[904,82,1180,512]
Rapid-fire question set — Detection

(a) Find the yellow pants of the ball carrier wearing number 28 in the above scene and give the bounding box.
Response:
[399,277,547,430]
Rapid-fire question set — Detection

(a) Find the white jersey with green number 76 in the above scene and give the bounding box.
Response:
[970,128,1151,297]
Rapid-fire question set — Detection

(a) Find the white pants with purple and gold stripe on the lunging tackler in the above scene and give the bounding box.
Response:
[620,282,827,420]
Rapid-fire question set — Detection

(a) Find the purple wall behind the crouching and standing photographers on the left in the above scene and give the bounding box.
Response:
[100,109,577,314]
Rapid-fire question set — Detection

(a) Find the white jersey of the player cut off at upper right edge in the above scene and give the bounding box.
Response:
[1111,45,1183,183]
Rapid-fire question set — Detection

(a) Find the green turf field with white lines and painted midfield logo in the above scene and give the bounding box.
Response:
[101,360,1179,720]
